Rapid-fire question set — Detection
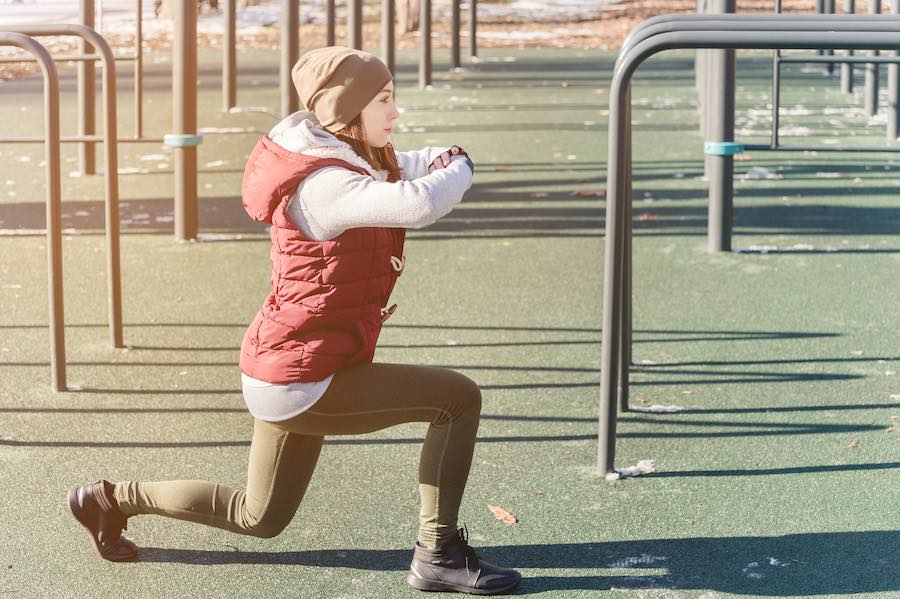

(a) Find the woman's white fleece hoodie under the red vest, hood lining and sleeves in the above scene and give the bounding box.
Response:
[269,111,472,241]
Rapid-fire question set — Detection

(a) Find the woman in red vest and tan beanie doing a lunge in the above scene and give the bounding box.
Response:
[69,46,520,595]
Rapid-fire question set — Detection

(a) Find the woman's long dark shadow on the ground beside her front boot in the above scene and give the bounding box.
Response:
[139,530,900,597]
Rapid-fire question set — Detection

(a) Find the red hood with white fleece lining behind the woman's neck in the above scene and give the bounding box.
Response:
[241,110,388,222]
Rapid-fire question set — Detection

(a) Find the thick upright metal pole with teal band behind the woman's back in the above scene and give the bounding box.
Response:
[172,0,197,241]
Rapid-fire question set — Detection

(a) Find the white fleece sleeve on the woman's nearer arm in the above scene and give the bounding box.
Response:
[287,161,472,241]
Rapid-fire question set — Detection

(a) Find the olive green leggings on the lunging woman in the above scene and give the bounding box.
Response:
[114,364,481,548]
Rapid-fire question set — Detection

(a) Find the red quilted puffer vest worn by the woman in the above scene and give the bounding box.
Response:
[240,137,406,384]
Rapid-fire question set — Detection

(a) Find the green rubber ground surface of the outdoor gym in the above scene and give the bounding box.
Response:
[0,44,900,599]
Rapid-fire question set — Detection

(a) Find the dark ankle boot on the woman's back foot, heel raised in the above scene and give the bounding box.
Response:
[69,480,138,562]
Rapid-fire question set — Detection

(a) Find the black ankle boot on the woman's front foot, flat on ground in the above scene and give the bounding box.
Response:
[406,528,522,595]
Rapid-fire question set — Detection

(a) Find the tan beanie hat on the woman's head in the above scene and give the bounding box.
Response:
[291,46,394,132]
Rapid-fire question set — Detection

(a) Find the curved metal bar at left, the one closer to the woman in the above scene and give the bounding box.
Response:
[3,24,124,347]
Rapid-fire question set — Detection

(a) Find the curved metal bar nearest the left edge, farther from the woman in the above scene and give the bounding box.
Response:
[0,32,66,391]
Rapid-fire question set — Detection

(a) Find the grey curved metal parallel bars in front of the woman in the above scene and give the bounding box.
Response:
[597,15,900,474]
